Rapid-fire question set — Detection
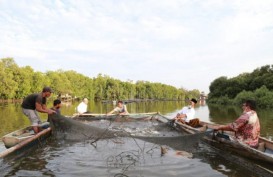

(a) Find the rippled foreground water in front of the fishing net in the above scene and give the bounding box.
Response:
[0,137,263,177]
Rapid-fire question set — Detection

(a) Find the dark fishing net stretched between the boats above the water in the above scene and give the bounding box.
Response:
[49,114,204,152]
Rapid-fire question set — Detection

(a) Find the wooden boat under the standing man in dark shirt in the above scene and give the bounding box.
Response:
[0,122,51,158]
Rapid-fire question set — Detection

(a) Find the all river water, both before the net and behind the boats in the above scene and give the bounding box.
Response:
[0,101,273,177]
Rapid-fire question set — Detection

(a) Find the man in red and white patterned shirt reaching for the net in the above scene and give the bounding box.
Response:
[214,100,260,148]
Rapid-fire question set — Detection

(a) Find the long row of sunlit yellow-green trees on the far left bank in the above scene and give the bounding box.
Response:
[0,58,200,100]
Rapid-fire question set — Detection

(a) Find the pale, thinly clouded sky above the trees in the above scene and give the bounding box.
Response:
[0,0,273,93]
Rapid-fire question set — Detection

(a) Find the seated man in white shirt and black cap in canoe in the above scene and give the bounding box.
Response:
[174,98,199,127]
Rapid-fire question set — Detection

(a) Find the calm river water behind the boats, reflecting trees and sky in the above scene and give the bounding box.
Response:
[0,101,273,138]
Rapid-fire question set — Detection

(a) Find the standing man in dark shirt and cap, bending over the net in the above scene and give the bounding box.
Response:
[21,87,56,133]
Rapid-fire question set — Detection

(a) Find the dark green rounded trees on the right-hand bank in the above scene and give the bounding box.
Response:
[208,65,273,108]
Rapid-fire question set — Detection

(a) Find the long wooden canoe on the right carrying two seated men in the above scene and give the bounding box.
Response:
[171,121,273,164]
